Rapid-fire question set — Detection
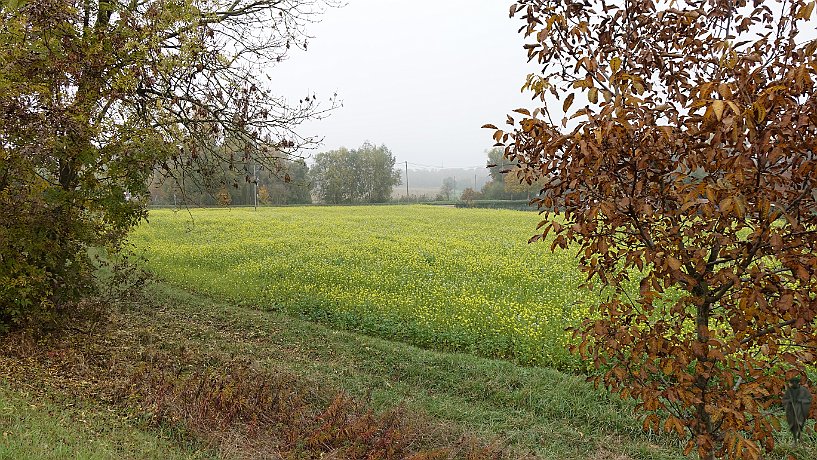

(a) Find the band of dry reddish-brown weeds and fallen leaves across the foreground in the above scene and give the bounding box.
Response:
[0,296,524,460]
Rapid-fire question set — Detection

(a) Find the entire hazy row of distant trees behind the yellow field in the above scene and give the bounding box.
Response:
[150,142,528,206]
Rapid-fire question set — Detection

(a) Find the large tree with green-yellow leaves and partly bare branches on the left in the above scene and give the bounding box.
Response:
[0,0,334,325]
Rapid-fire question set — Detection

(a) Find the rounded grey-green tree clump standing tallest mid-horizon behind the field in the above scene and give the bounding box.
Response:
[309,142,400,204]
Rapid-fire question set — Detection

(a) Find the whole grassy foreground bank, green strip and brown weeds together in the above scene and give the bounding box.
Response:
[0,283,817,460]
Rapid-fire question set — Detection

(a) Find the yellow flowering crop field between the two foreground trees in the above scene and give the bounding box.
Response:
[131,205,599,369]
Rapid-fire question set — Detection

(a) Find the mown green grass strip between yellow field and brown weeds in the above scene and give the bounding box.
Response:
[128,284,696,460]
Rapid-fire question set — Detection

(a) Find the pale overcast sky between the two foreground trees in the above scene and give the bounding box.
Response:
[271,0,535,167]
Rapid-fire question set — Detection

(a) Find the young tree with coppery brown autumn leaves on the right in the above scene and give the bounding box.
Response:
[486,0,817,459]
